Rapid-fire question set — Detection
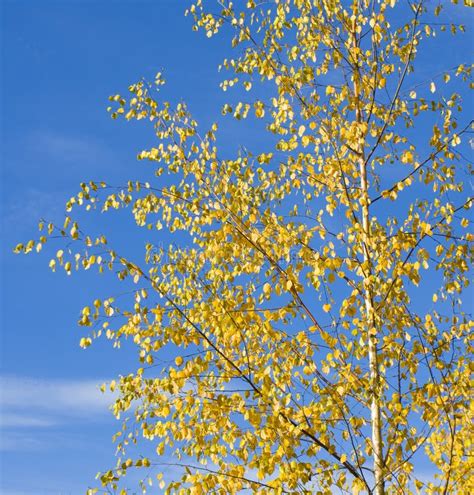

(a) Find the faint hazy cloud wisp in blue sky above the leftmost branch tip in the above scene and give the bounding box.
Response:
[2,129,118,231]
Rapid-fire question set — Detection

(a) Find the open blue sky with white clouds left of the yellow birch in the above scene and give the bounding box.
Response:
[0,0,474,495]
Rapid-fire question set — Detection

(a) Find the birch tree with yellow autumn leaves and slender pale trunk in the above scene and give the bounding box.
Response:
[17,0,474,495]
